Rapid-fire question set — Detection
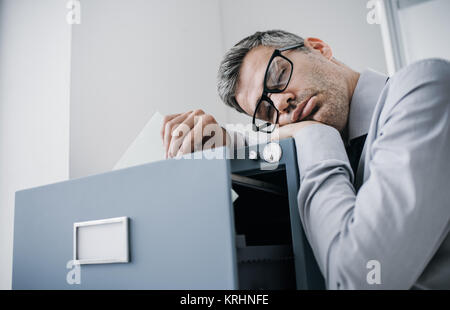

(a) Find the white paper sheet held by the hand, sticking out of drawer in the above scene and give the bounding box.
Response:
[113,111,165,170]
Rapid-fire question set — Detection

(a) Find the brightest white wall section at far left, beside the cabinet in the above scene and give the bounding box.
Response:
[0,0,70,289]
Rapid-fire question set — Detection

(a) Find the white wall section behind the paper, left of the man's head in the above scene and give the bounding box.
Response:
[70,0,226,178]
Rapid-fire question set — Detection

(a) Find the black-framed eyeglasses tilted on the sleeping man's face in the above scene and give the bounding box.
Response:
[252,43,304,133]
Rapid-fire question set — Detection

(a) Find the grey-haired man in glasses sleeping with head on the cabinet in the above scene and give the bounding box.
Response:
[162,30,450,289]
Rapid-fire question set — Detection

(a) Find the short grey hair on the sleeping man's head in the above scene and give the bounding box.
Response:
[217,30,308,113]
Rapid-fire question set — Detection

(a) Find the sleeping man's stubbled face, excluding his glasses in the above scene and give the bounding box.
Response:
[236,46,350,131]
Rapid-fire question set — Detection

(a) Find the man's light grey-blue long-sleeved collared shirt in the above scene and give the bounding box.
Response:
[294,59,450,289]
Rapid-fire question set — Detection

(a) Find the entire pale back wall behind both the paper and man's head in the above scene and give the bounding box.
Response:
[70,0,386,178]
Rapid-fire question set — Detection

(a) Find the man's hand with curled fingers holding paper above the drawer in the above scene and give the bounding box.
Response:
[161,110,229,158]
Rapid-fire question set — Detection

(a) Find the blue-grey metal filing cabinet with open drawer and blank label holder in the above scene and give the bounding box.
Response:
[12,139,324,289]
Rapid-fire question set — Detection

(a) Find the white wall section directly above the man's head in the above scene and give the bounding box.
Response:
[220,0,386,122]
